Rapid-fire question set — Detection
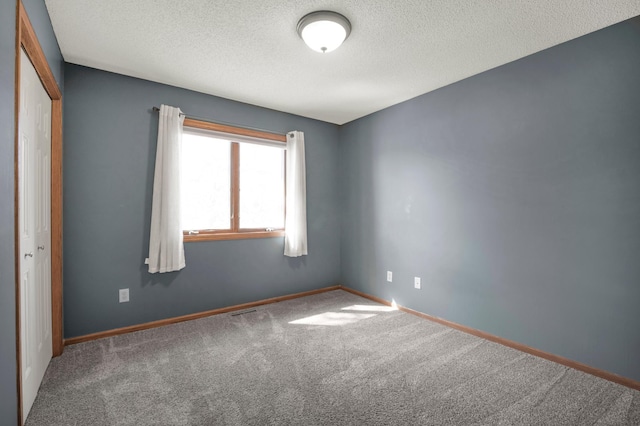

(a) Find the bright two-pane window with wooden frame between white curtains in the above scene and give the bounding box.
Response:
[181,118,286,241]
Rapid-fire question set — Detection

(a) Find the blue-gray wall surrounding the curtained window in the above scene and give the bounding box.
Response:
[64,64,340,337]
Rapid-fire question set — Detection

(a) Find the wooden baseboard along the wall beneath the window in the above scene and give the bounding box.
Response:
[64,285,342,346]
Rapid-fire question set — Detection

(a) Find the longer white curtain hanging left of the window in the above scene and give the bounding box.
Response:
[146,105,185,273]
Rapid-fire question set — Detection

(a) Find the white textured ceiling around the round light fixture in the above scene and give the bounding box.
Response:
[45,0,640,124]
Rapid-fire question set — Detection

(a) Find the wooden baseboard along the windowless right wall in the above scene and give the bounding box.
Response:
[340,286,640,391]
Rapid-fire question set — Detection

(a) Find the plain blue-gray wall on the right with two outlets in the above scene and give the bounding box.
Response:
[340,18,640,380]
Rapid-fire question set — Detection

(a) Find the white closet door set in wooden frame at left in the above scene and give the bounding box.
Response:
[18,46,52,420]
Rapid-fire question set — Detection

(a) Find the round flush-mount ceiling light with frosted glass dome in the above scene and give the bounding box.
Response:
[298,10,351,53]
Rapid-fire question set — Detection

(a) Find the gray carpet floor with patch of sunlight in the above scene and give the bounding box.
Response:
[26,290,640,426]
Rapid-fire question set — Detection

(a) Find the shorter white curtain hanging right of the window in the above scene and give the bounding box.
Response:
[284,131,307,257]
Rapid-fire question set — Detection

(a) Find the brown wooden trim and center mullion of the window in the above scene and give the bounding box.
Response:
[182,117,287,242]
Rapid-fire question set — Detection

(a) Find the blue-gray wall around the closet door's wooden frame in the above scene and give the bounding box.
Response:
[0,0,64,425]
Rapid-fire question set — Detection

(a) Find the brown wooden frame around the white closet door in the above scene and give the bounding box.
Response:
[14,0,64,425]
